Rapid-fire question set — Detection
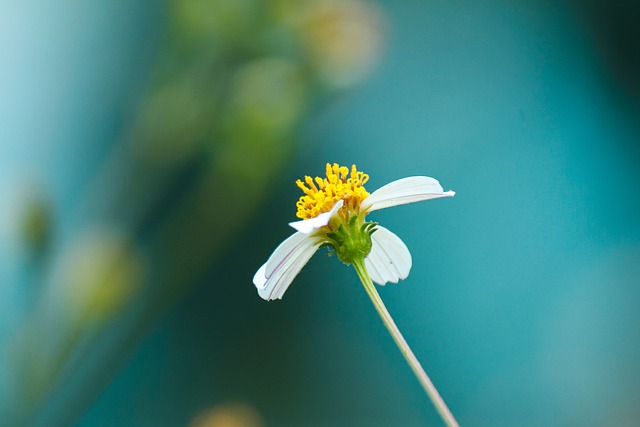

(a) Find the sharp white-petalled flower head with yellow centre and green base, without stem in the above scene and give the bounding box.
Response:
[253,164,455,300]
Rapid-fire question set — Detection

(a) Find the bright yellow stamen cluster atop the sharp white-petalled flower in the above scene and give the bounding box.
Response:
[296,163,369,219]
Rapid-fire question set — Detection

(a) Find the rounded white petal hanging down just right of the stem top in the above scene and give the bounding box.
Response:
[364,226,412,285]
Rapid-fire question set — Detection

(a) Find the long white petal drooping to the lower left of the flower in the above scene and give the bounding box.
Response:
[253,232,320,300]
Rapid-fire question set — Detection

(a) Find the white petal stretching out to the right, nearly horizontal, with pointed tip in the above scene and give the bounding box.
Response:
[360,176,456,212]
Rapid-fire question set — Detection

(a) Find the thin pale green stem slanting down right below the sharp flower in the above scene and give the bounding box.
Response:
[353,259,459,427]
